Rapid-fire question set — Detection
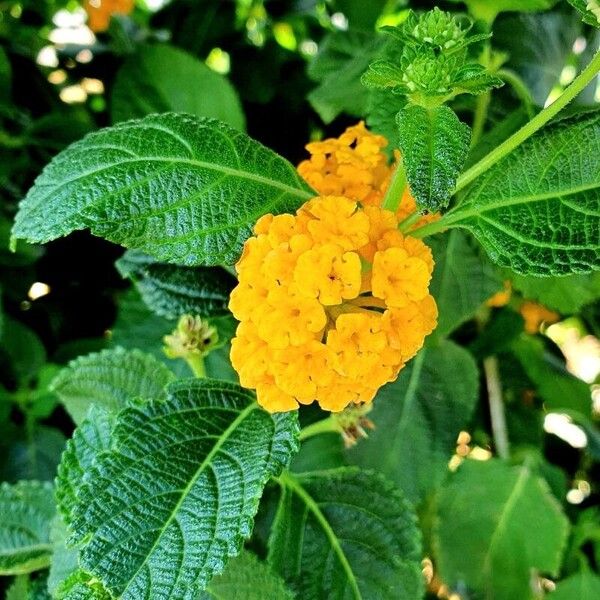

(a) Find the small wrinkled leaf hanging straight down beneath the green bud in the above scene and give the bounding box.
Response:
[396,105,471,212]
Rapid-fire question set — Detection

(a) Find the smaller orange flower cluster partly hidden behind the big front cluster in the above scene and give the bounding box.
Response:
[298,121,440,227]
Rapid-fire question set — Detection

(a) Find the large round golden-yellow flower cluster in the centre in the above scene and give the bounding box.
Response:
[229,195,437,412]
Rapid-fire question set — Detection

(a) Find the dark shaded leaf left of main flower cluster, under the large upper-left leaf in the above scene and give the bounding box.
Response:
[116,250,236,319]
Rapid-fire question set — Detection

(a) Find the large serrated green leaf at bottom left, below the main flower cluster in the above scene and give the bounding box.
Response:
[58,379,298,600]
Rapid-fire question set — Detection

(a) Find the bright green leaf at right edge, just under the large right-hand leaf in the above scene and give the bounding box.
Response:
[512,273,600,315]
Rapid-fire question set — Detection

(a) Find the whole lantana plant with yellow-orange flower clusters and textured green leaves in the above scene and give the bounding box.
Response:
[0,0,600,600]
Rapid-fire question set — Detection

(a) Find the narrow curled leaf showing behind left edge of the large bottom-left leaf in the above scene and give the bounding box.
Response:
[56,404,115,524]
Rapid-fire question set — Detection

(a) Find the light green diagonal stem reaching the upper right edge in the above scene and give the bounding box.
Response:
[455,52,600,192]
